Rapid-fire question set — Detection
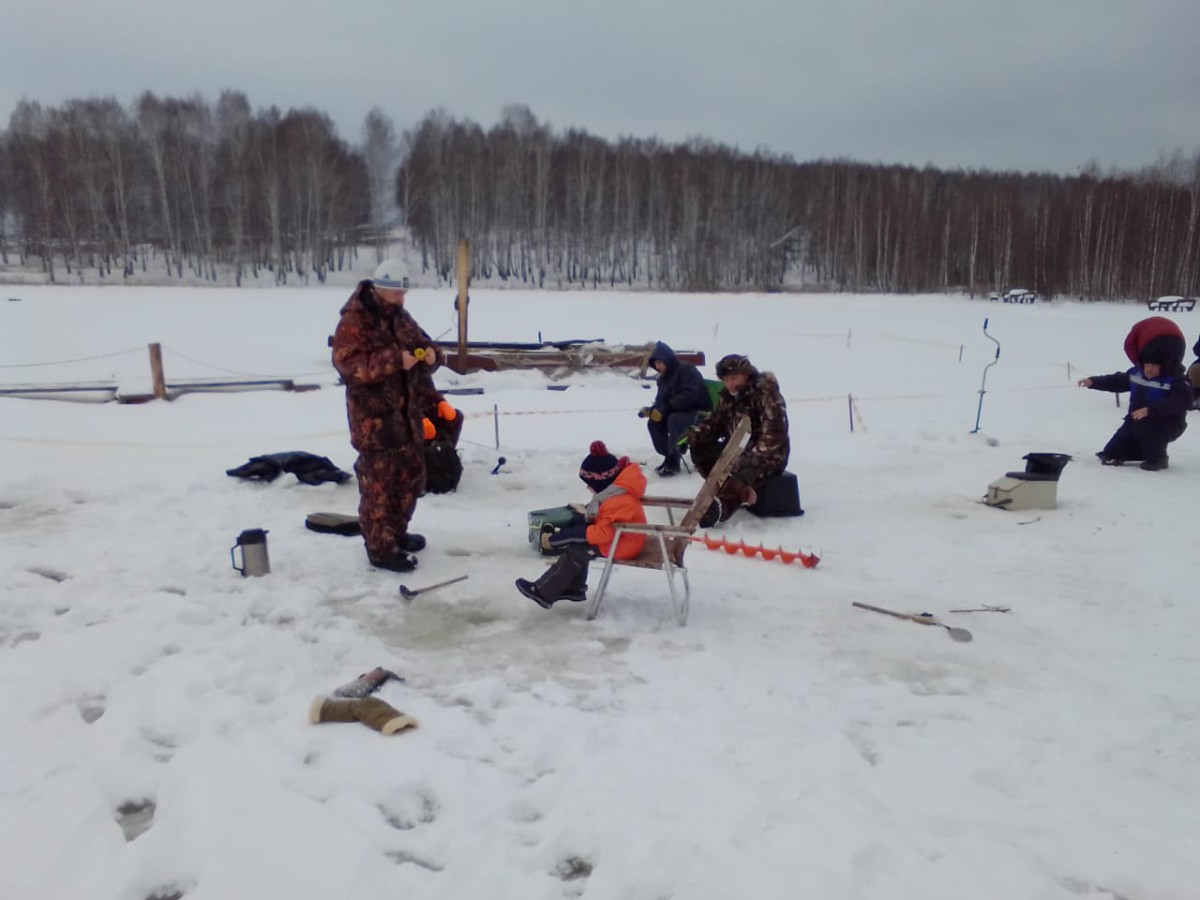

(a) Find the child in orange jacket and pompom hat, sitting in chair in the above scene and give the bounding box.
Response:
[516,440,646,610]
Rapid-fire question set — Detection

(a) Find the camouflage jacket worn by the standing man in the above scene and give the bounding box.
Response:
[334,281,442,452]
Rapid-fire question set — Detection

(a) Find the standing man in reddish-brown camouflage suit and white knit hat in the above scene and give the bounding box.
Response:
[334,259,440,572]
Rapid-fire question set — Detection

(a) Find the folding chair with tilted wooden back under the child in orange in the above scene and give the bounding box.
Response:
[587,415,750,625]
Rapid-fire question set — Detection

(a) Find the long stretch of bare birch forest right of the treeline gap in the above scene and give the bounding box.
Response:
[400,107,1200,299]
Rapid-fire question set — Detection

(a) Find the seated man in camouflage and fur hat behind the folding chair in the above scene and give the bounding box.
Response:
[688,353,791,528]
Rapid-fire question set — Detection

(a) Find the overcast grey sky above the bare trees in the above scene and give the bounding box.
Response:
[0,0,1200,173]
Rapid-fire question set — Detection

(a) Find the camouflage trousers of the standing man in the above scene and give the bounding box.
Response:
[354,444,425,562]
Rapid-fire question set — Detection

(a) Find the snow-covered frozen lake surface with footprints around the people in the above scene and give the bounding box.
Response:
[0,287,1200,900]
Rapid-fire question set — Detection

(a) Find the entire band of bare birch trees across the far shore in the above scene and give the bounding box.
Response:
[0,91,1200,299]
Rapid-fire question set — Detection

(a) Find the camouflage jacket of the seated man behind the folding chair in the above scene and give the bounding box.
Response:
[691,372,791,474]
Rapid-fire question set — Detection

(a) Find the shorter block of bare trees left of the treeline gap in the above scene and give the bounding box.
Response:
[0,91,398,283]
